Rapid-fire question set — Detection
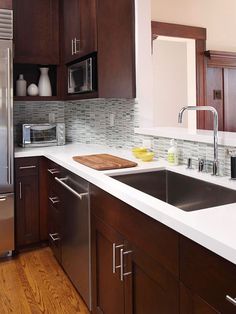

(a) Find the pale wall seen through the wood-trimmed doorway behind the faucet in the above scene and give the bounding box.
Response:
[152,37,188,127]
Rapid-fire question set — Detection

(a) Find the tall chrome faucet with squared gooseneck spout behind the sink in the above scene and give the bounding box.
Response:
[178,106,219,176]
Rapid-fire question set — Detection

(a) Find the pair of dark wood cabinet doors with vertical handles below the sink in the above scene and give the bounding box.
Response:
[91,188,179,314]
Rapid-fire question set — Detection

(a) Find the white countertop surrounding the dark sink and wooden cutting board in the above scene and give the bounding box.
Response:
[15,144,236,264]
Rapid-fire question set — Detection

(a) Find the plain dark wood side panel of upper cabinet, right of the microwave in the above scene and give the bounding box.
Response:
[97,0,136,98]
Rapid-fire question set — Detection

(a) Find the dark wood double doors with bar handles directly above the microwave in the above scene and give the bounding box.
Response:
[62,0,97,63]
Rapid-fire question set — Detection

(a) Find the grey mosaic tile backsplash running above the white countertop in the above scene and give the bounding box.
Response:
[14,99,235,175]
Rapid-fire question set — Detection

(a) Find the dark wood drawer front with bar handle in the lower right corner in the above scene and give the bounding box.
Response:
[180,237,236,314]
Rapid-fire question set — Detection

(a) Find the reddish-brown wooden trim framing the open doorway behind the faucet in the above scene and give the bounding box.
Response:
[151,21,207,129]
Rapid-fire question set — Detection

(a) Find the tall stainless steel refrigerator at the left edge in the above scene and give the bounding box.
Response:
[0,9,15,256]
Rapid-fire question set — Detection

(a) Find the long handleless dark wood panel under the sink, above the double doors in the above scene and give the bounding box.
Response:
[90,186,179,277]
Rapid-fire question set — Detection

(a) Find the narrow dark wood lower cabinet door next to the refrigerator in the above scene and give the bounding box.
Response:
[16,176,39,248]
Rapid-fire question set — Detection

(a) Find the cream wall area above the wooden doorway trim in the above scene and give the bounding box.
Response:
[150,0,236,51]
